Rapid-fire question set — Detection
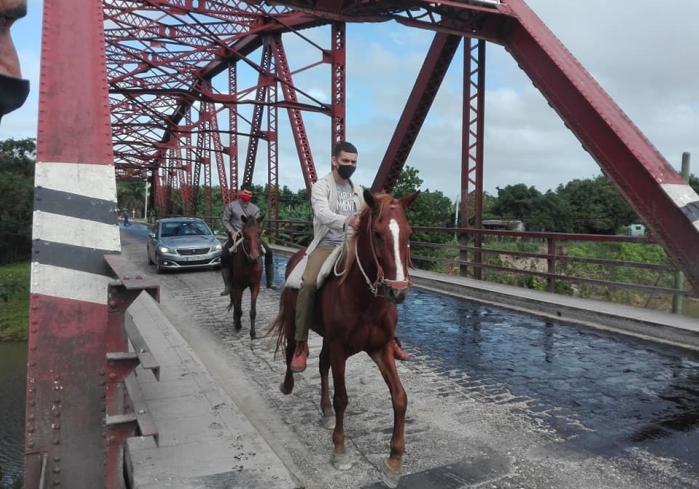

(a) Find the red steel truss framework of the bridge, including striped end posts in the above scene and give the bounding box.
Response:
[25,0,699,488]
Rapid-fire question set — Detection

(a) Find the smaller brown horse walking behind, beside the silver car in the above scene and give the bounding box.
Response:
[227,216,262,340]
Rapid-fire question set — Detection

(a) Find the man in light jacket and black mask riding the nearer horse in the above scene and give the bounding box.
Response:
[291,141,410,372]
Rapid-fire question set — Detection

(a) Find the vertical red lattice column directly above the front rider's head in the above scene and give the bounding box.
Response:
[330,22,347,150]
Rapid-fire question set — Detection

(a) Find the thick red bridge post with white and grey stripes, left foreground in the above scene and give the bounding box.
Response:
[24,0,125,489]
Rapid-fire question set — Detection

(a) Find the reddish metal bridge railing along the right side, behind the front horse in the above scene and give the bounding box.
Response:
[267,219,696,309]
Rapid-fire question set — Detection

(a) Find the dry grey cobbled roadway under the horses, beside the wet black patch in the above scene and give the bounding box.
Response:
[122,228,699,489]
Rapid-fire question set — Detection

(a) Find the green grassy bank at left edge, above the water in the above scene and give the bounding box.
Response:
[0,262,30,341]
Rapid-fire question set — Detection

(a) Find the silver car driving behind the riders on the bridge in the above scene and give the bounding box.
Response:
[146,217,222,273]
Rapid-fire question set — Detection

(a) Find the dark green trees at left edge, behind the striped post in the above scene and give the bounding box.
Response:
[0,139,36,264]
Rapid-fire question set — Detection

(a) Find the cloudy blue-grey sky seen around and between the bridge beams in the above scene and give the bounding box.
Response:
[0,0,699,198]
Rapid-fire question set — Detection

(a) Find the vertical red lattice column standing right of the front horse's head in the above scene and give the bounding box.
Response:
[460,37,485,279]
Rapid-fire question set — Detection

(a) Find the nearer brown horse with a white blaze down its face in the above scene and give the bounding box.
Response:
[273,190,417,487]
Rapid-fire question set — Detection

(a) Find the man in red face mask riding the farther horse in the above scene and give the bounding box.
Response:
[221,183,277,295]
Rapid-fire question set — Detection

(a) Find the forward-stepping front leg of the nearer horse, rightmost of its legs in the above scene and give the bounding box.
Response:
[371,343,408,487]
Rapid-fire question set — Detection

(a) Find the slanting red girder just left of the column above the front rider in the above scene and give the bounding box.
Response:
[271,34,318,190]
